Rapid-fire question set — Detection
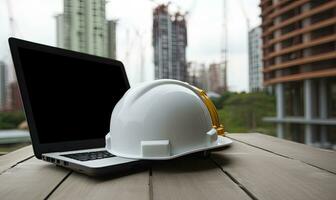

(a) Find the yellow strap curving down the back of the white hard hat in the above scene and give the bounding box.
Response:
[194,86,224,135]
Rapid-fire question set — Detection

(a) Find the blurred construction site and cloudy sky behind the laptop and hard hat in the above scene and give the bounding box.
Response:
[0,0,336,155]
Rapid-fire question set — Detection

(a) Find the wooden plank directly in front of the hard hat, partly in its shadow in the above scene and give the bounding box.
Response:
[152,158,250,200]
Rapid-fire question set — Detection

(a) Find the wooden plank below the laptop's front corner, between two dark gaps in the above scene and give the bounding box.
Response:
[49,171,149,200]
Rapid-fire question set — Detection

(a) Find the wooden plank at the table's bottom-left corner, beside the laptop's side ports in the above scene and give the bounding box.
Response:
[0,158,69,200]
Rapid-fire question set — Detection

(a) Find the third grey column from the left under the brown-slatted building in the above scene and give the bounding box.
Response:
[319,78,328,146]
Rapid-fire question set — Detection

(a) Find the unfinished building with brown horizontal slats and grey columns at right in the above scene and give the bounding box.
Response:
[260,0,336,148]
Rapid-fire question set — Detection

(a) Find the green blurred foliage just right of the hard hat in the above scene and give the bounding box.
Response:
[214,92,275,135]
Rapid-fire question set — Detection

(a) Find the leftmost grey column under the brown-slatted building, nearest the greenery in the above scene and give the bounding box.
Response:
[275,83,285,138]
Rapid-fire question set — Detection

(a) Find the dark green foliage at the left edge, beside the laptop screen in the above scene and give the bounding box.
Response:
[0,112,26,129]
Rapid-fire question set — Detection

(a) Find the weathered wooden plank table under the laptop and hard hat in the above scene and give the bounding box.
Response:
[0,134,336,200]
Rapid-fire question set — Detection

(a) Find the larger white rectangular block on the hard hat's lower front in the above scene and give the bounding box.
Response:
[141,140,170,157]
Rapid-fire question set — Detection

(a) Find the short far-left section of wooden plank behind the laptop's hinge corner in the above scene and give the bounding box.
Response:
[0,145,34,174]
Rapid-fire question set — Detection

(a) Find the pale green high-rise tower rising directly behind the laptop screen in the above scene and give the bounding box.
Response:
[56,0,116,58]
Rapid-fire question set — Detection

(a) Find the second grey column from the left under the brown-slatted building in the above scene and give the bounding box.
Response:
[303,79,313,144]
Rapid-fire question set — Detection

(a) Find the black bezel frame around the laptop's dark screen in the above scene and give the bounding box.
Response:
[8,37,130,159]
